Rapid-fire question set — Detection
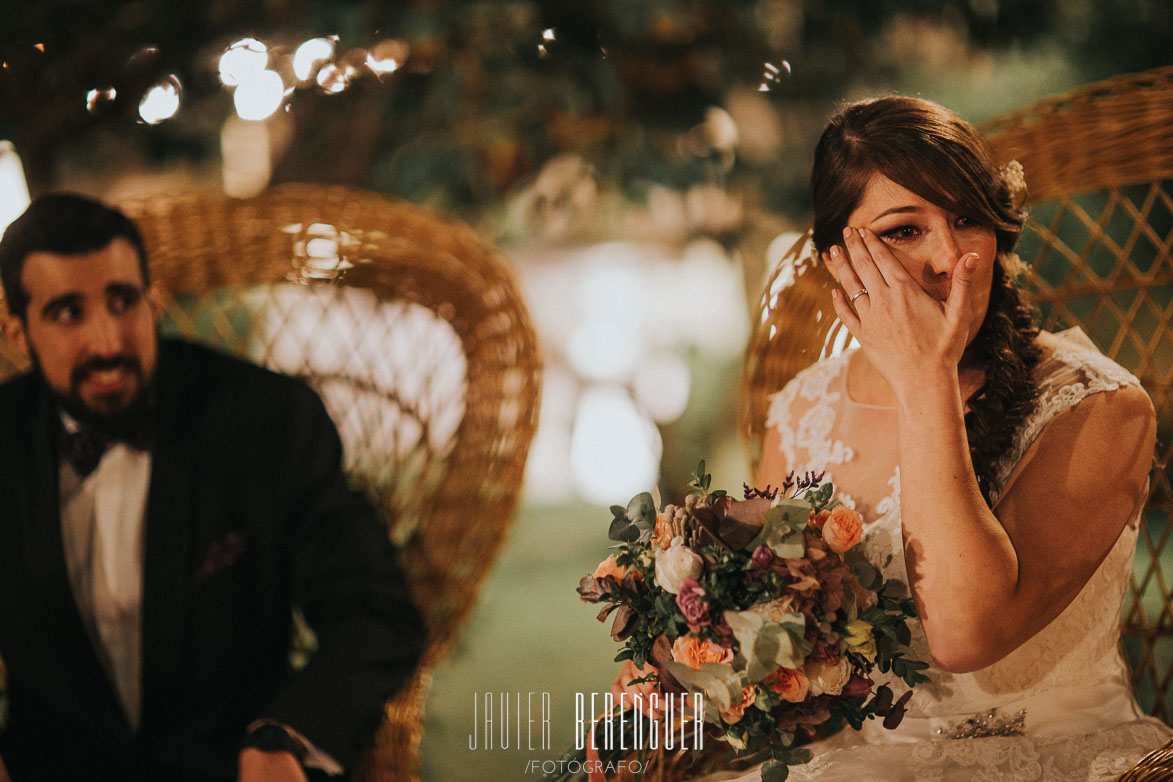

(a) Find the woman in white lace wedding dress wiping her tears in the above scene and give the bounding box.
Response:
[711,97,1171,782]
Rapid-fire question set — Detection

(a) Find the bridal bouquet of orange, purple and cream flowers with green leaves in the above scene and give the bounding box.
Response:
[567,462,928,782]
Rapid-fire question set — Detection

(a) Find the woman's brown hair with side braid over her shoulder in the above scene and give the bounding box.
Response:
[811,97,1040,503]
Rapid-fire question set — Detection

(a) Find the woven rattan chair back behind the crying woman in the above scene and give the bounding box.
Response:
[739,68,1173,722]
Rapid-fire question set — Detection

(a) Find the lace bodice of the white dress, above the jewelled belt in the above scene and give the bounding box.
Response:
[768,332,1154,740]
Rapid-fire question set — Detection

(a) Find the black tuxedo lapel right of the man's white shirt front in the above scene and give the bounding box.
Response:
[142,342,198,726]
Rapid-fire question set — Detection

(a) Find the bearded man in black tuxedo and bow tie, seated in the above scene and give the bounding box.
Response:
[0,195,423,782]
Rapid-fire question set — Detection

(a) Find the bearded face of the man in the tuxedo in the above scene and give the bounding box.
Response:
[8,237,161,422]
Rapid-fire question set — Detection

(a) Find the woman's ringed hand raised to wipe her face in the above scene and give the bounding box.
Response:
[823,227,989,395]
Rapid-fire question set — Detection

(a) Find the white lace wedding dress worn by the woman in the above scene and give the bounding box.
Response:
[708,329,1171,782]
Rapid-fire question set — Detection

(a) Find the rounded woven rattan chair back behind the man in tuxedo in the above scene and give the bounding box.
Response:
[0,185,540,782]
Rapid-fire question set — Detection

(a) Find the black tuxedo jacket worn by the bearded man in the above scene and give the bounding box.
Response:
[0,340,423,782]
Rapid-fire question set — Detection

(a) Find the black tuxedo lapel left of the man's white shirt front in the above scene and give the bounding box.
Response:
[19,384,129,739]
